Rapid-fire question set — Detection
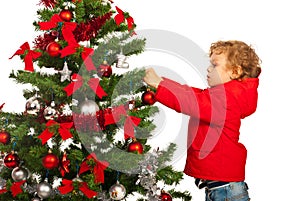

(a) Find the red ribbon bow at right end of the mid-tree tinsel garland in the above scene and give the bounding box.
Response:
[104,105,141,140]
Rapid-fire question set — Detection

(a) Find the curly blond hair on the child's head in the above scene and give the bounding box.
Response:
[209,40,261,79]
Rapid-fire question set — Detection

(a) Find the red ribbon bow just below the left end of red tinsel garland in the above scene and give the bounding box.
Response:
[38,120,73,145]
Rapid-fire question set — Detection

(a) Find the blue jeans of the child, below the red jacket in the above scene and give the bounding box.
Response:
[205,182,250,201]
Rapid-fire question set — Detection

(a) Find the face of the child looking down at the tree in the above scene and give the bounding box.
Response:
[207,53,232,87]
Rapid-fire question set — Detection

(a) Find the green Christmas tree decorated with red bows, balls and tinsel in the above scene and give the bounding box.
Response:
[0,0,191,201]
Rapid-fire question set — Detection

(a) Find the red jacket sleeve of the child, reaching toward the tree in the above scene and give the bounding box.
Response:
[156,78,226,124]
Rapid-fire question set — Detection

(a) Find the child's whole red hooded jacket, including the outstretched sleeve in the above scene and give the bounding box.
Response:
[156,78,259,181]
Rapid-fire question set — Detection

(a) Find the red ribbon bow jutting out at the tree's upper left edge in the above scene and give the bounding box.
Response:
[9,42,42,72]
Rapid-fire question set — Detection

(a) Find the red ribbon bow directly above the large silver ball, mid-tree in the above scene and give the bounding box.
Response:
[64,73,107,98]
